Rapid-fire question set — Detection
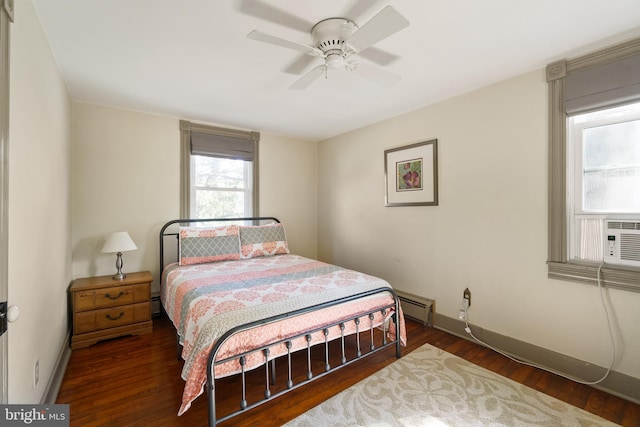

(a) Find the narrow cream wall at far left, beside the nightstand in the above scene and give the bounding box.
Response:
[8,1,71,403]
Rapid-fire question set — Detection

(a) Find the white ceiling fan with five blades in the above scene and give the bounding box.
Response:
[241,0,409,90]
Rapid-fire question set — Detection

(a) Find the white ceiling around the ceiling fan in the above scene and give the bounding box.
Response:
[32,0,640,140]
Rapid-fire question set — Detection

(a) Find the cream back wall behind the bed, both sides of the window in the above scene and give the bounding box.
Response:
[72,102,317,289]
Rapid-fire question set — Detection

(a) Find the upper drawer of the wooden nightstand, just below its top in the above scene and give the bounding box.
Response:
[74,283,150,311]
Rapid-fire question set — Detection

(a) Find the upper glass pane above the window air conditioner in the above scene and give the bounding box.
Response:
[582,120,640,213]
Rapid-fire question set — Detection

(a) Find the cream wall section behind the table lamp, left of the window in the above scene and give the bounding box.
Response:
[71,102,180,286]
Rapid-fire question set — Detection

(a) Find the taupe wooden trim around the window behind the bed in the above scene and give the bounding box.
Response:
[180,120,260,219]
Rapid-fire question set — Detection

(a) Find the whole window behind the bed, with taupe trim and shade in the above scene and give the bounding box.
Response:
[180,121,260,218]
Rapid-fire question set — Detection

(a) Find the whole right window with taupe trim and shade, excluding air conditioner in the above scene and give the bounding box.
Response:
[547,38,640,292]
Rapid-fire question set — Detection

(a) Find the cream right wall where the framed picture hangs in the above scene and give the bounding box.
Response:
[318,70,640,378]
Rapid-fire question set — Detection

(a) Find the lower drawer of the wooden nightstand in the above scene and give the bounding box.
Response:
[74,302,151,334]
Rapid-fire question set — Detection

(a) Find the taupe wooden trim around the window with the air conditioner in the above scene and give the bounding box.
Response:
[546,38,640,292]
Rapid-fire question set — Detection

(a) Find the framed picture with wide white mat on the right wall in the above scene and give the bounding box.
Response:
[384,139,438,206]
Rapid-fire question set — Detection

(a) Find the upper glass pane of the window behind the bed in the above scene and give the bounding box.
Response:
[193,156,245,188]
